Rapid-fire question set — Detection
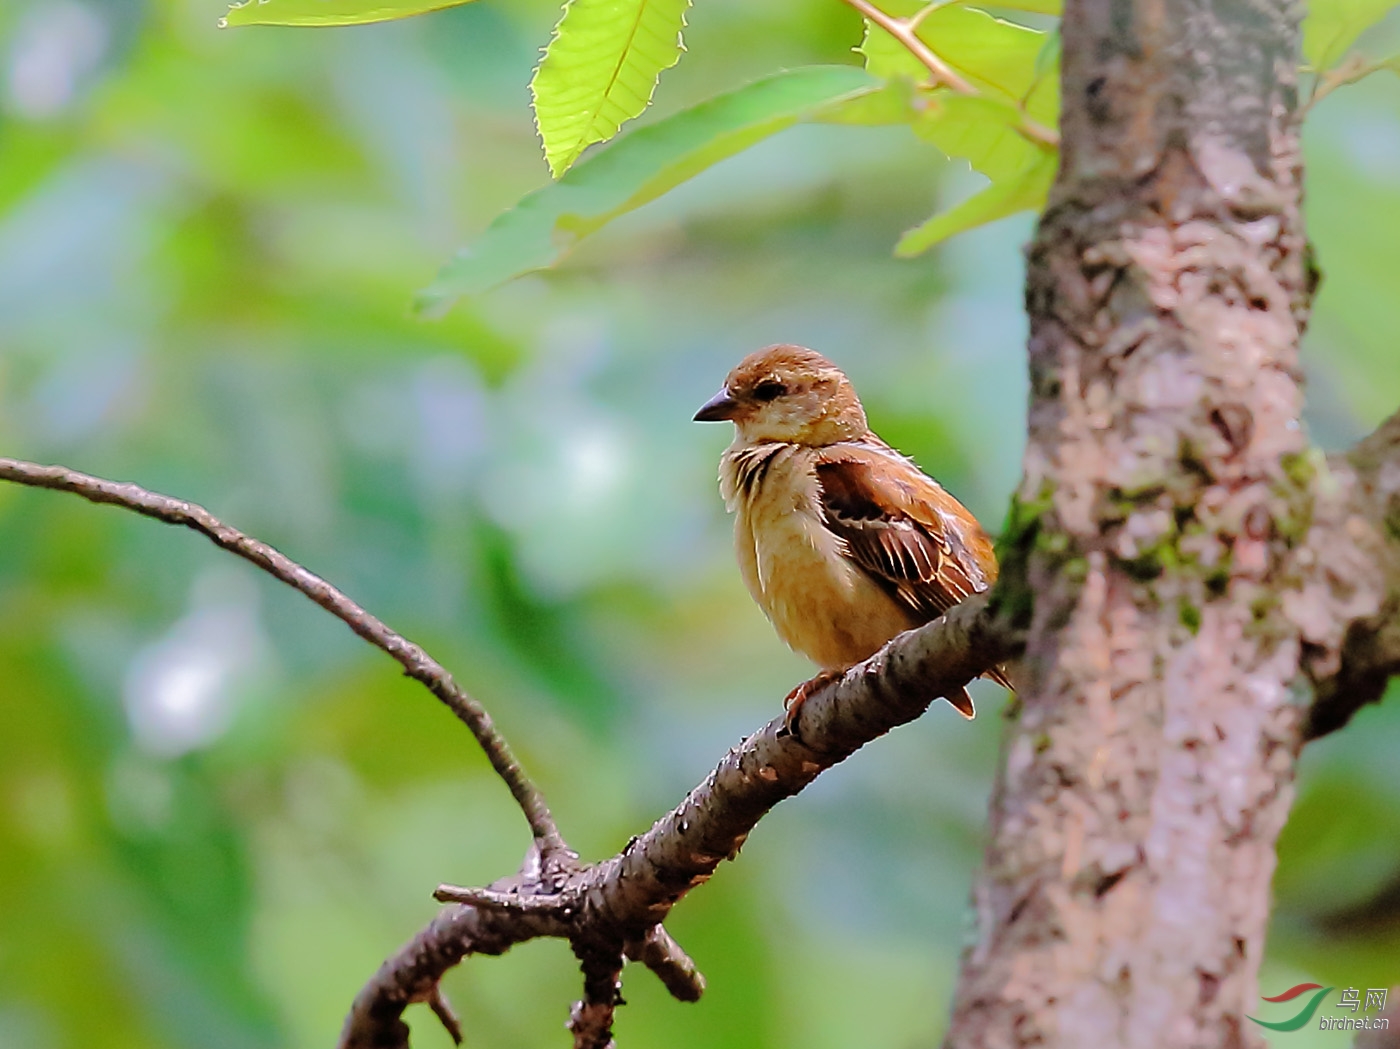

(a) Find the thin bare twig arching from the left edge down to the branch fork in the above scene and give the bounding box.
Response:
[0,457,573,868]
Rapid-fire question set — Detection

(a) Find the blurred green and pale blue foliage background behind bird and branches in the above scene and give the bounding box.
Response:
[0,0,1400,1049]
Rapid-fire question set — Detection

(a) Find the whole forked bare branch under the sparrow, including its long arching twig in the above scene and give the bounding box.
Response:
[0,458,1023,1049]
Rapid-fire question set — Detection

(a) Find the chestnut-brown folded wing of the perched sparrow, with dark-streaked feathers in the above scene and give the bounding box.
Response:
[816,438,1011,688]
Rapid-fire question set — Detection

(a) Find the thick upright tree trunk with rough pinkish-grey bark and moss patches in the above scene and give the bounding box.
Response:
[946,0,1316,1049]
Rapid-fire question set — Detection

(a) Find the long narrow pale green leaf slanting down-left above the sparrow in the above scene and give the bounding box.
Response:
[417,66,879,312]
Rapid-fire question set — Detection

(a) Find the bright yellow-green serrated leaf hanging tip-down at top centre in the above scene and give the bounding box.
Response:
[529,0,690,178]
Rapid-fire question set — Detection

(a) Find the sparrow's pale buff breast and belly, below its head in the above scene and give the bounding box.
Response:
[720,444,917,669]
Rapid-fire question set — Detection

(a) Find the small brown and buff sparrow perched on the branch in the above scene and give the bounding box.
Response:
[694,345,1011,731]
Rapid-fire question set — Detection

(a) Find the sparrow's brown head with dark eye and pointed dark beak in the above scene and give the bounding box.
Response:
[696,345,868,447]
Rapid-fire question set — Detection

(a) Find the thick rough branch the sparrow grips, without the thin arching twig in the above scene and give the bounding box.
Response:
[340,594,1022,1049]
